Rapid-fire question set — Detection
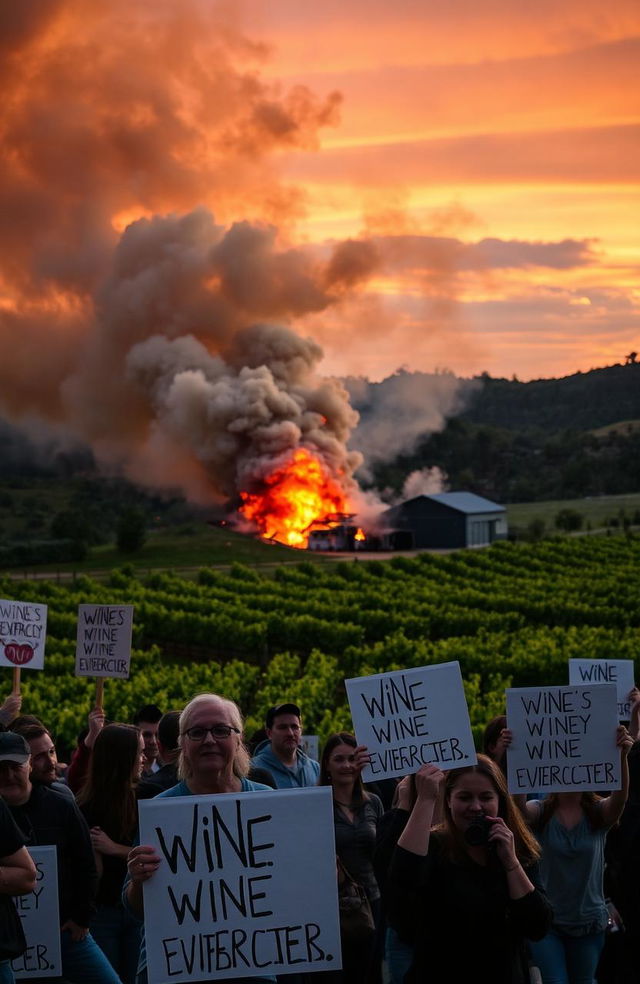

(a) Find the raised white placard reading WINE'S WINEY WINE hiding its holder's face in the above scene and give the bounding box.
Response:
[506,683,621,793]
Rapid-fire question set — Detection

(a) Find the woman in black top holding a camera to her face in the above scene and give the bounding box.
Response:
[389,755,551,984]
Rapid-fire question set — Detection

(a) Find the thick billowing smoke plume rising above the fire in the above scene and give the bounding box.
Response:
[0,0,470,516]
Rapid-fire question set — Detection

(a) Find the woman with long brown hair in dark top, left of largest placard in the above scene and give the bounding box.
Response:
[78,724,144,984]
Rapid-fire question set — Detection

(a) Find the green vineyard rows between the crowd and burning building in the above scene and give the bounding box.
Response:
[0,536,640,743]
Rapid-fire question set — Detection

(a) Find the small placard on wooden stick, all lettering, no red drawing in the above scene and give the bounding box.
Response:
[76,605,133,679]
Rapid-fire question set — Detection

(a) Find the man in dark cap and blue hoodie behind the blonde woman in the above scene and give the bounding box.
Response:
[251,704,320,789]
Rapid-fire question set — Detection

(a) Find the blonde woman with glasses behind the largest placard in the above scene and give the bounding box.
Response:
[124,694,275,984]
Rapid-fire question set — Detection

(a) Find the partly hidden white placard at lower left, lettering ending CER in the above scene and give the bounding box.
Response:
[11,847,62,981]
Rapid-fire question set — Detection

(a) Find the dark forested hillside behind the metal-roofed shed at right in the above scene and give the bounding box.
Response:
[365,364,640,502]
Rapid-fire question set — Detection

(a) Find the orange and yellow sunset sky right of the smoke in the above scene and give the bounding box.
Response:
[247,0,640,379]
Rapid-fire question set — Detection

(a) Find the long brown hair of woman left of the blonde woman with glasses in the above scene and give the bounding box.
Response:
[78,724,140,842]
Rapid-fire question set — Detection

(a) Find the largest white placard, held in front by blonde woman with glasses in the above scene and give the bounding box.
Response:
[139,787,341,984]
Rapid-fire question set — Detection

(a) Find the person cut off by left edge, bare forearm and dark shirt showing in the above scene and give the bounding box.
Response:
[0,799,36,984]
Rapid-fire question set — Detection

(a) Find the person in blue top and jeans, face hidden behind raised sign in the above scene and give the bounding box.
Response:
[524,725,633,984]
